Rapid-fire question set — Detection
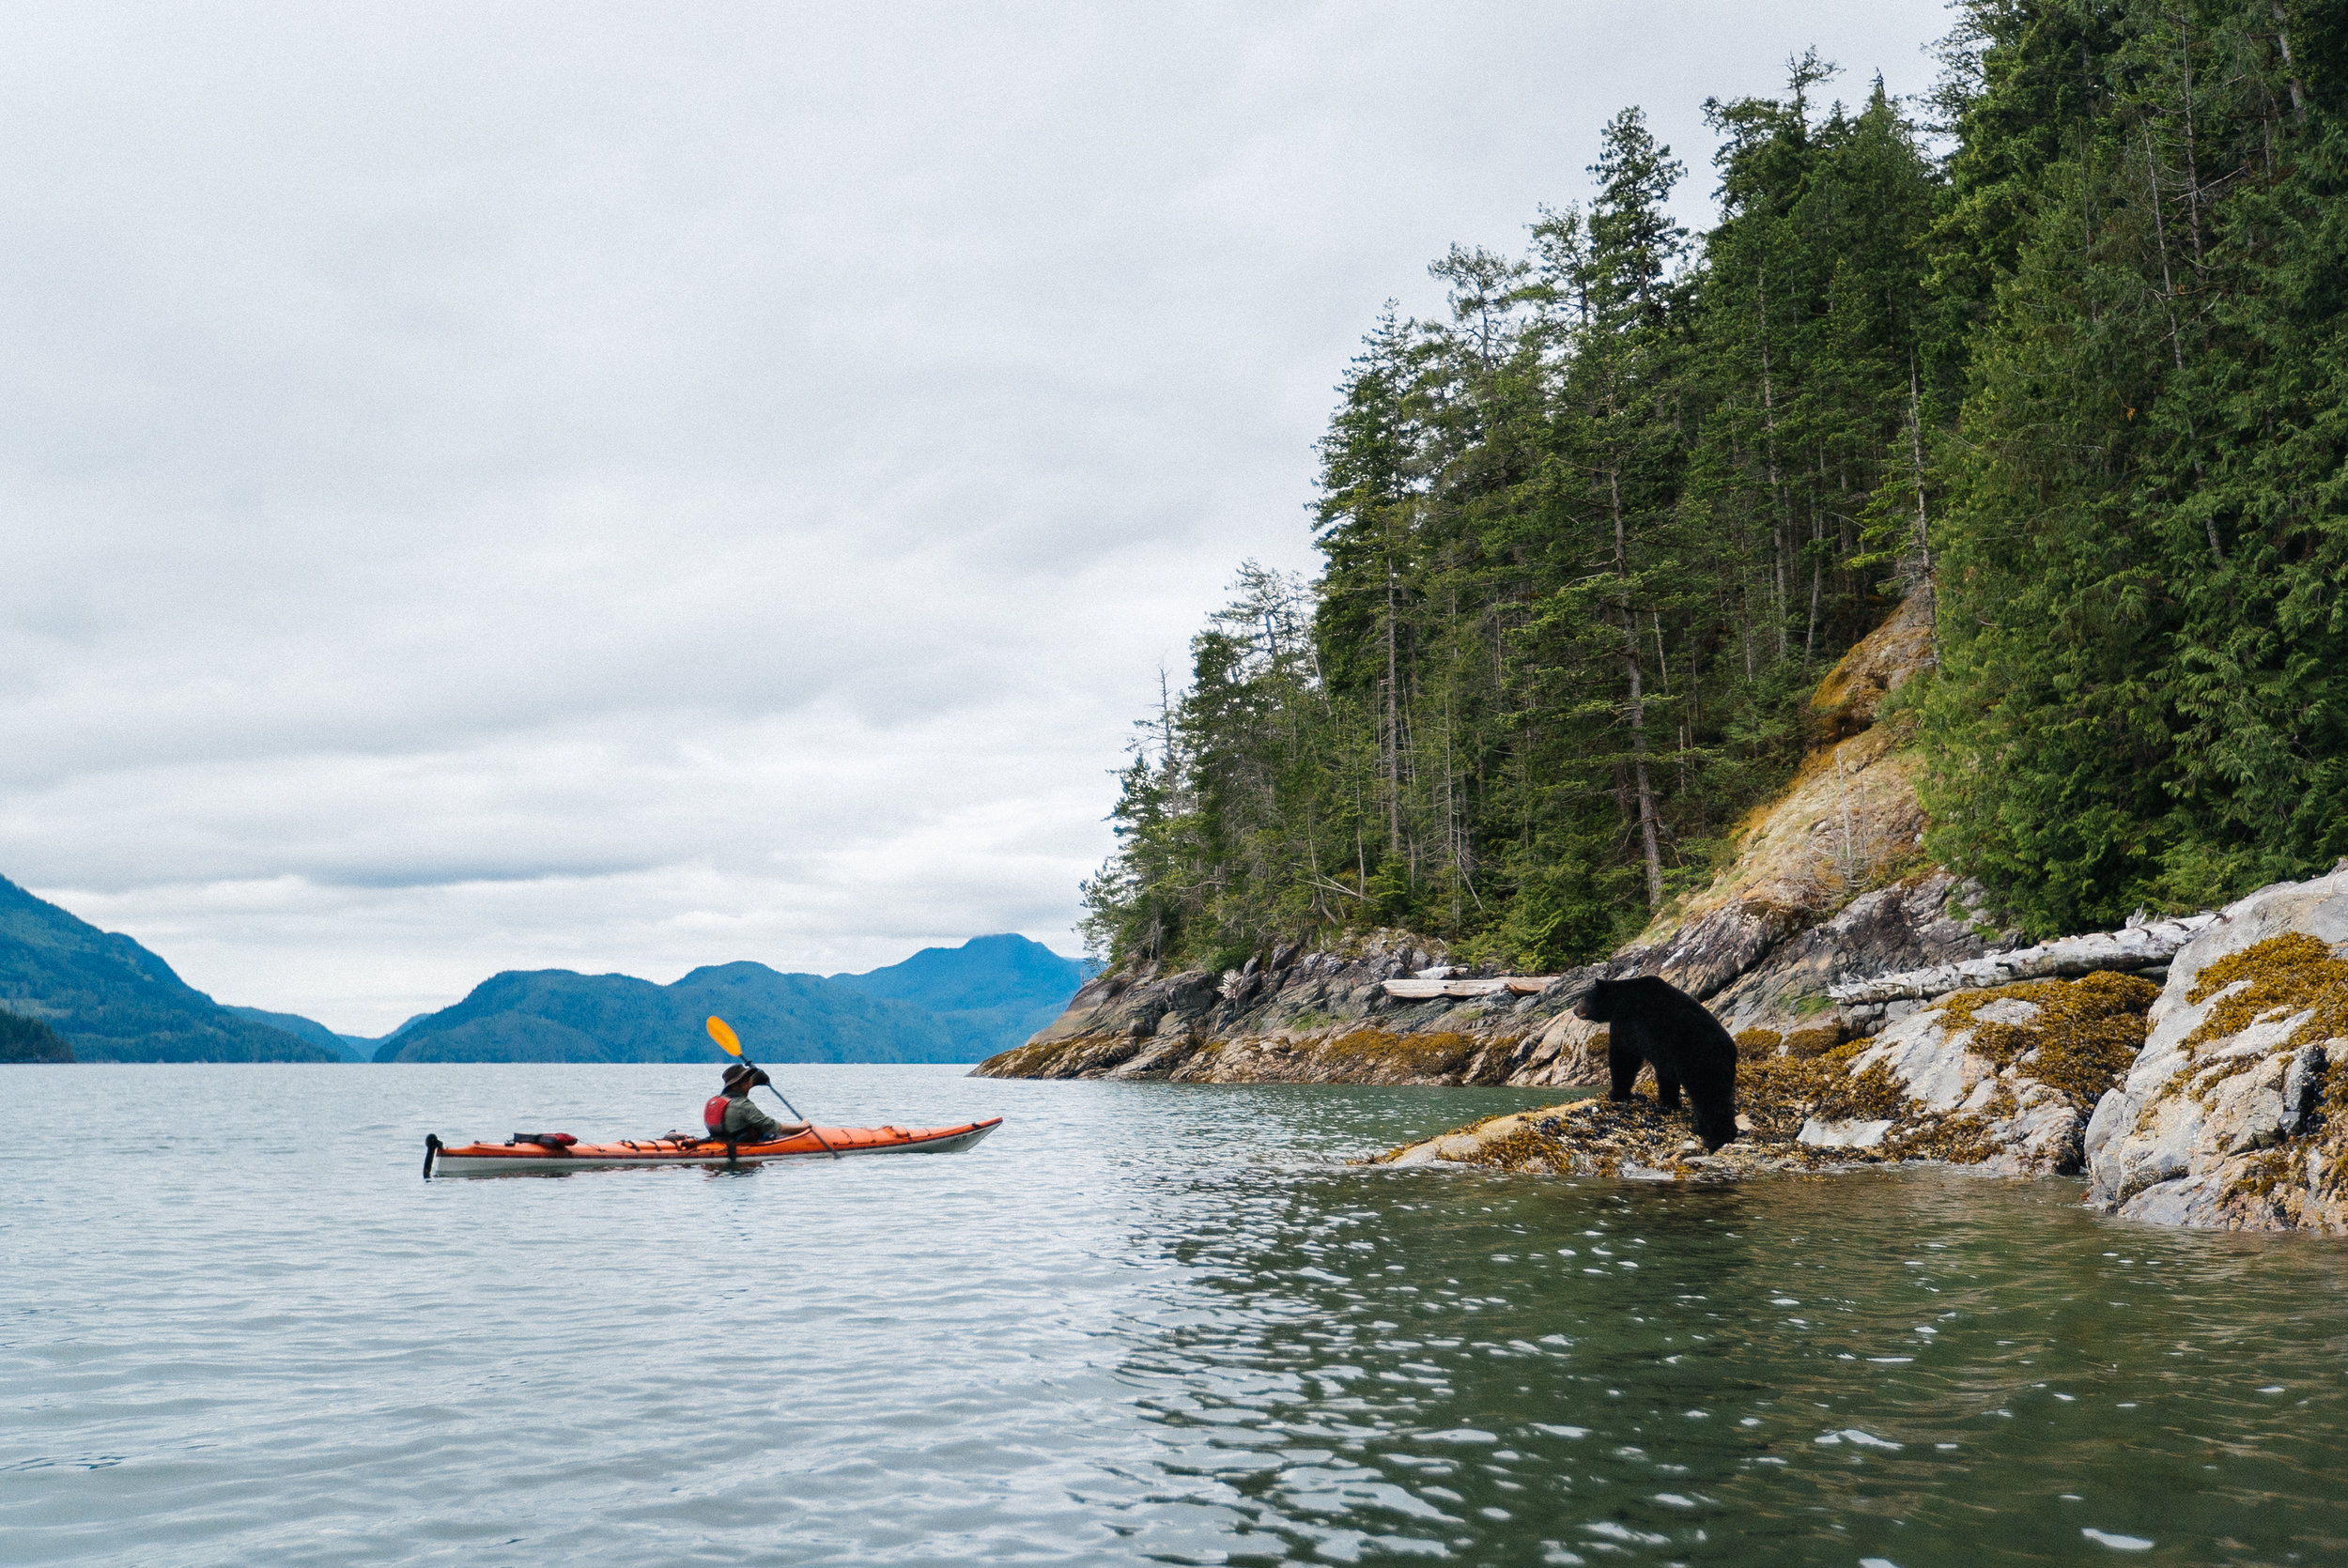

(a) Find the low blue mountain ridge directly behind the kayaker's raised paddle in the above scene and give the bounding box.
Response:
[376,962,977,1066]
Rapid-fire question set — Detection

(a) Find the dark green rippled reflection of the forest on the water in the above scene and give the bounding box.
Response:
[1127,1174,2348,1568]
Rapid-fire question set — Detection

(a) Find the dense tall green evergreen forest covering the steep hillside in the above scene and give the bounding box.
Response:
[1088,0,2348,967]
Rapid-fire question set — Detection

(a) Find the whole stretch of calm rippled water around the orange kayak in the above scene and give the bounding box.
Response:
[0,1066,2348,1568]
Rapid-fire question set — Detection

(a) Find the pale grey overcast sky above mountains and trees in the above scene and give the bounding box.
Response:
[0,0,1947,1033]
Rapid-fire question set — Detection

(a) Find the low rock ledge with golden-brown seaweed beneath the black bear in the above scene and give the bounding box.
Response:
[1381,975,2160,1176]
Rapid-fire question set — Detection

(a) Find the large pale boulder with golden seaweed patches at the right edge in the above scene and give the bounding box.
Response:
[2088,862,2348,1235]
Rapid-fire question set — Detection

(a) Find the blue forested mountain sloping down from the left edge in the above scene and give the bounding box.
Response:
[0,878,338,1061]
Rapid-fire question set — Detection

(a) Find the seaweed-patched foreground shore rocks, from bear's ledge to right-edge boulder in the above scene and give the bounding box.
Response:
[1379,862,2348,1235]
